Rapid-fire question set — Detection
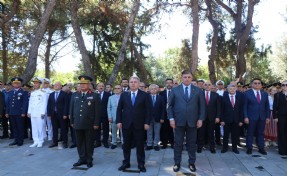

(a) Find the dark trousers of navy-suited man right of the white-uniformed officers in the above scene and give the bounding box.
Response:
[51,112,68,144]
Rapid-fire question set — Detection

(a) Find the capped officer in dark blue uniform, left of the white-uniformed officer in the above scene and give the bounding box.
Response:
[5,77,28,146]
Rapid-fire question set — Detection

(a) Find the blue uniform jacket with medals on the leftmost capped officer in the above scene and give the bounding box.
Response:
[6,88,28,115]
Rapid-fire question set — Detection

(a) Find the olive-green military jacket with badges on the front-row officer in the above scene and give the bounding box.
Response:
[69,91,101,130]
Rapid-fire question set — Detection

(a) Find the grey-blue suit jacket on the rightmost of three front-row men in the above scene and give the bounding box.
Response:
[168,84,206,127]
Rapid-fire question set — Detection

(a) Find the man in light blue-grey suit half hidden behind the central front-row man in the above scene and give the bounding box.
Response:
[107,85,123,149]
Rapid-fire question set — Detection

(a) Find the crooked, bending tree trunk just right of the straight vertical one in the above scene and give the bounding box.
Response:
[205,0,219,84]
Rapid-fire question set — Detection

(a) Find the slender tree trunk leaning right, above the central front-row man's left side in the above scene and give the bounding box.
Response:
[108,1,140,84]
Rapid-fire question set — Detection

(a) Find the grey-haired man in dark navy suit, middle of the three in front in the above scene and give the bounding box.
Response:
[116,76,151,172]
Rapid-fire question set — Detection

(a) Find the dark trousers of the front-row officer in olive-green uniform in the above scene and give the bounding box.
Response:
[74,128,94,162]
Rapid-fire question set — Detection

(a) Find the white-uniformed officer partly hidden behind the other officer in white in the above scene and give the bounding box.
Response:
[43,78,54,141]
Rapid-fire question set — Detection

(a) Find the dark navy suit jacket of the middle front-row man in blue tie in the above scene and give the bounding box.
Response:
[116,89,151,129]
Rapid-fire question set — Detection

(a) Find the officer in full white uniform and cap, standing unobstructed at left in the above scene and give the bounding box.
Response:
[27,77,47,147]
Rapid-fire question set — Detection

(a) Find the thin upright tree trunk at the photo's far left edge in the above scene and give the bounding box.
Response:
[1,25,8,83]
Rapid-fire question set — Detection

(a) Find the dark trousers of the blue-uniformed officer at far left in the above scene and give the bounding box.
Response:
[9,115,25,144]
